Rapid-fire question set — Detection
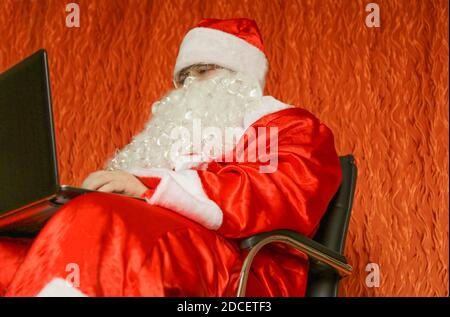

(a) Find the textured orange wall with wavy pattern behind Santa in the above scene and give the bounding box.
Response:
[0,0,449,296]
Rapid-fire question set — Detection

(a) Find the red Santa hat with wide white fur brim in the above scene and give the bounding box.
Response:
[174,18,268,89]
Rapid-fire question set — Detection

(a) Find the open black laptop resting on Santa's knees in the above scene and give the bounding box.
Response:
[0,50,142,236]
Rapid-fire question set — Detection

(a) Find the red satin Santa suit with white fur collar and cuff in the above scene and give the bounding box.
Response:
[0,20,341,296]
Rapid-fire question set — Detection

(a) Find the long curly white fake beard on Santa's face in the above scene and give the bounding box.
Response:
[105,69,262,171]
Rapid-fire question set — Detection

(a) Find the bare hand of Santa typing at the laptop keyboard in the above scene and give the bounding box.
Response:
[81,170,148,197]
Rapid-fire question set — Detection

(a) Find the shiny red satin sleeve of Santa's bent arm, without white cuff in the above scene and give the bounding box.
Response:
[198,108,342,238]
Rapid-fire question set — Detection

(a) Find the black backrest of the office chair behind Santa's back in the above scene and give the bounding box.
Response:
[306,155,357,297]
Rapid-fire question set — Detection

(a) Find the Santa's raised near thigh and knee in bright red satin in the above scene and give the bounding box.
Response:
[4,193,240,296]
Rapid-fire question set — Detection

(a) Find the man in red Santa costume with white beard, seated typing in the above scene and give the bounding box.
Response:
[0,19,341,296]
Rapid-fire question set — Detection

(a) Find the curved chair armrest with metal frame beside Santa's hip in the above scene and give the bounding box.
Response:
[237,230,352,297]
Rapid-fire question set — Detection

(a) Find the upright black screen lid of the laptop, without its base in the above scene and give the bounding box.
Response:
[0,50,58,216]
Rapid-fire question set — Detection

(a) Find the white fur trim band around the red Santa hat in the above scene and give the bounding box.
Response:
[174,27,268,89]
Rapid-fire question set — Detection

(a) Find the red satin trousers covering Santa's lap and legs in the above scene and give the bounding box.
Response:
[0,193,307,296]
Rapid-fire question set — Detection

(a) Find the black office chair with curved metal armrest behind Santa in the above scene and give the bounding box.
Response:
[237,155,357,297]
